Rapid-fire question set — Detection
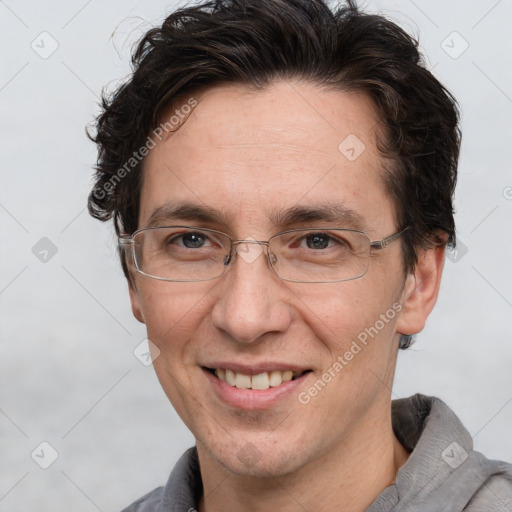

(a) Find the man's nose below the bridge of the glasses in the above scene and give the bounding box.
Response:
[212,242,292,344]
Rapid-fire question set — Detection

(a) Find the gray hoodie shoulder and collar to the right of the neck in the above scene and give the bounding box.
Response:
[388,395,512,512]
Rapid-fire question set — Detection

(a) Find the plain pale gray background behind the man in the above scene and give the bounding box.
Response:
[0,0,512,512]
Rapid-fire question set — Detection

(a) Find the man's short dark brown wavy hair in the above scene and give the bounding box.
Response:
[88,0,460,284]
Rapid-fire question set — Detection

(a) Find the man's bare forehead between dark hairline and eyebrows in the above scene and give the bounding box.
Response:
[139,81,392,236]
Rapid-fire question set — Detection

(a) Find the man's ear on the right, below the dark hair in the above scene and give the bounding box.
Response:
[396,245,445,334]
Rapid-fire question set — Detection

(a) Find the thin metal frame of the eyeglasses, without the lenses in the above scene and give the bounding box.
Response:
[118,226,411,284]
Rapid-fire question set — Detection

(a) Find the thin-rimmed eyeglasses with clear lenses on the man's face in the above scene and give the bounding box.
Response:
[119,226,409,283]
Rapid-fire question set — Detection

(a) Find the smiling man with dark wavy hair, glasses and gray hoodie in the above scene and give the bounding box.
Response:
[89,0,512,512]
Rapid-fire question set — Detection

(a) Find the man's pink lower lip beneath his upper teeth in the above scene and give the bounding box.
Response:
[203,368,310,411]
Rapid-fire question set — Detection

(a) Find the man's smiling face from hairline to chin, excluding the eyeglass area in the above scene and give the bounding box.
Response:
[130,81,416,475]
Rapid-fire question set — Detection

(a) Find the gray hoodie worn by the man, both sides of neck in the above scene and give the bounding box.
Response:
[123,395,512,512]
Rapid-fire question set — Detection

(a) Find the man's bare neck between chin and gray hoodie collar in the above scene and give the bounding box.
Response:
[198,408,408,512]
